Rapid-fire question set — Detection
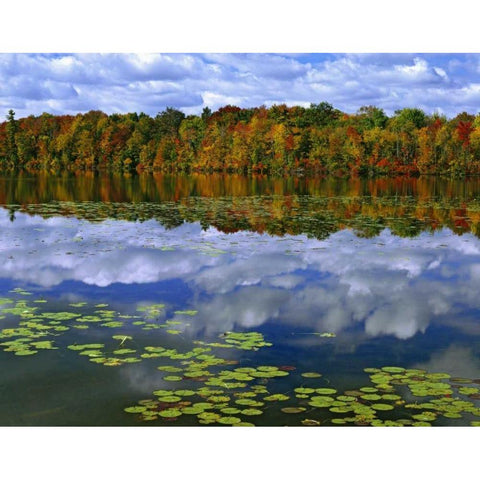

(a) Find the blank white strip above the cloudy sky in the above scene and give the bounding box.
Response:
[0,0,480,53]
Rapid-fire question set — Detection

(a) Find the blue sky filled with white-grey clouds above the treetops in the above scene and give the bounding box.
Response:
[0,53,480,117]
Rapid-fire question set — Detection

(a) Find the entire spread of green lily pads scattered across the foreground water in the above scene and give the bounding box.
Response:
[0,288,480,426]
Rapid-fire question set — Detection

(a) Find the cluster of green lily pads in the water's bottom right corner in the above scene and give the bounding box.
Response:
[295,366,480,426]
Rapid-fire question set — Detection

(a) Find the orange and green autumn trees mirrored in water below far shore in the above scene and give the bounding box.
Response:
[0,173,480,239]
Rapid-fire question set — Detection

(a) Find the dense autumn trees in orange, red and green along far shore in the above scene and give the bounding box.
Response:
[0,102,480,176]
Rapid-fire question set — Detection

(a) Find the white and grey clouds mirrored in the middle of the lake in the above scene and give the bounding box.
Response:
[0,211,480,339]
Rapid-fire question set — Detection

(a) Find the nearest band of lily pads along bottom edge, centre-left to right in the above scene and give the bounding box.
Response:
[125,366,480,426]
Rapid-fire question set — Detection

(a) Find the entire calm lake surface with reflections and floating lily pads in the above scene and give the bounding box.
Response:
[0,175,480,426]
